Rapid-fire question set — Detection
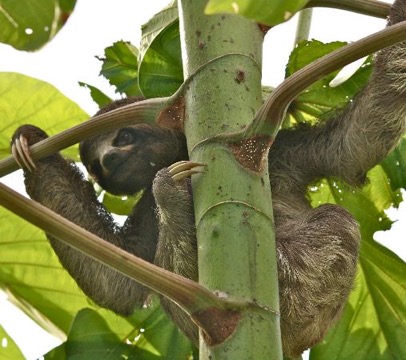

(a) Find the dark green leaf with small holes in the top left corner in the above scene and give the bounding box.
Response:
[0,0,76,51]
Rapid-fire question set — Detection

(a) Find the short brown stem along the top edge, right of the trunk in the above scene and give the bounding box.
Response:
[306,0,391,19]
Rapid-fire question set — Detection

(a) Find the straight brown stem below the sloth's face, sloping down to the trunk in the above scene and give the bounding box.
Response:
[0,183,233,315]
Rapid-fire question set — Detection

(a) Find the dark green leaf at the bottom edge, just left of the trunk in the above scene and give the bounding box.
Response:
[45,299,192,360]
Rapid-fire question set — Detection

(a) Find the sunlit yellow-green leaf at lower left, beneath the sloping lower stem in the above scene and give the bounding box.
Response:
[0,207,89,335]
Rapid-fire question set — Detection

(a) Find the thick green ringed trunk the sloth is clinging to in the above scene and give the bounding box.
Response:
[178,0,282,360]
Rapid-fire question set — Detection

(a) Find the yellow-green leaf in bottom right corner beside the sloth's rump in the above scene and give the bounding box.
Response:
[310,242,406,360]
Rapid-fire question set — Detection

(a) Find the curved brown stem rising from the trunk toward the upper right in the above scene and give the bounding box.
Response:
[249,21,406,137]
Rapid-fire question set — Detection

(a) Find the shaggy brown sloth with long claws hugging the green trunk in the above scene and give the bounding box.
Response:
[12,0,406,357]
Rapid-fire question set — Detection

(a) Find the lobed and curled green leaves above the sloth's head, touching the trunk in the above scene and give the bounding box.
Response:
[96,3,183,99]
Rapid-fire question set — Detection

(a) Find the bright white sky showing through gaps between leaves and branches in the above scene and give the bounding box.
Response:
[0,0,406,359]
